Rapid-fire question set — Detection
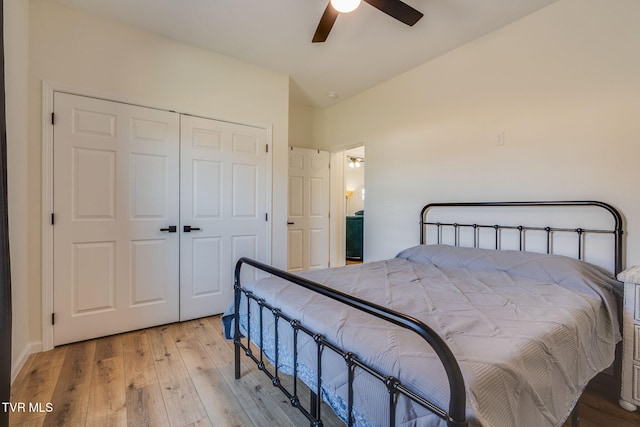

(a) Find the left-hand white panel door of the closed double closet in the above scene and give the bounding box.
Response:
[53,92,180,345]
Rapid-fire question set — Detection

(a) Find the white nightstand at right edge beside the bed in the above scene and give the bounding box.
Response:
[618,266,640,411]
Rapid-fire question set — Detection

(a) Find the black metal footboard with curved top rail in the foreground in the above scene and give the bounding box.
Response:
[233,258,467,427]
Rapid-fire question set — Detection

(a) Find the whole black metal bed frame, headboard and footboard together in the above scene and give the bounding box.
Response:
[233,201,623,427]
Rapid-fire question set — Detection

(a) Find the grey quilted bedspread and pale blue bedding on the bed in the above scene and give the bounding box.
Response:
[223,245,621,427]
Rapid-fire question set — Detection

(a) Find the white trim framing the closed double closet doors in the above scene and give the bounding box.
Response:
[40,80,273,351]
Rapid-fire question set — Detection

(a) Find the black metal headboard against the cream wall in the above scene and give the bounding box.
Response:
[420,201,623,275]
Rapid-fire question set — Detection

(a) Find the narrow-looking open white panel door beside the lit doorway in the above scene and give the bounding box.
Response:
[287,147,331,271]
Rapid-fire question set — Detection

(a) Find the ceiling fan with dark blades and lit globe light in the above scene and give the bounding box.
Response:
[312,0,424,43]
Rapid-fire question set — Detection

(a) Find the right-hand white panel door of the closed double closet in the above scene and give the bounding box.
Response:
[180,116,268,320]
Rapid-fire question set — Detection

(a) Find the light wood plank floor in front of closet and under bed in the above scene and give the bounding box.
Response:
[10,316,640,427]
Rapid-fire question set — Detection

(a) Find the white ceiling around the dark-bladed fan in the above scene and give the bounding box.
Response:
[49,0,557,107]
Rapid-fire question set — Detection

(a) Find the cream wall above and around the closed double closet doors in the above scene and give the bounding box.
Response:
[28,0,289,352]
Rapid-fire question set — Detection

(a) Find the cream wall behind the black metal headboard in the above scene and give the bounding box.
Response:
[317,0,640,265]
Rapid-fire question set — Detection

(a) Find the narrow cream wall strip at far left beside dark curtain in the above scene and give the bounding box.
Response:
[3,0,30,379]
